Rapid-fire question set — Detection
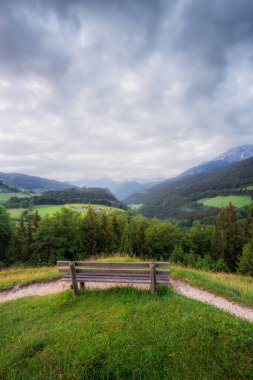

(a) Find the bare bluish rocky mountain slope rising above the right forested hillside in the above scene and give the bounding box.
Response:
[181,145,253,176]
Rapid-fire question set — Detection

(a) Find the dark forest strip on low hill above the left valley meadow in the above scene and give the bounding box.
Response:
[6,187,125,208]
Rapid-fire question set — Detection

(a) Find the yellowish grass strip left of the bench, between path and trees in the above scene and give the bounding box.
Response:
[0,267,61,291]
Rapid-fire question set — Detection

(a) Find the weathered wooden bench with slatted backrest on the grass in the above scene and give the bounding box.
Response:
[57,261,170,294]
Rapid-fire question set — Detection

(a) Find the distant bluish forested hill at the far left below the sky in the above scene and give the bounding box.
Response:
[0,172,70,192]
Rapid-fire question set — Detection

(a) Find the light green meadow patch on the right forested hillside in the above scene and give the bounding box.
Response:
[198,195,252,208]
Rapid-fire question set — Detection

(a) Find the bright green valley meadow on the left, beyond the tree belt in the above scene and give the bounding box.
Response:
[8,203,125,220]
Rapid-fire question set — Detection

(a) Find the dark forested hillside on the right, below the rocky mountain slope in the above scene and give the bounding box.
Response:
[125,158,253,218]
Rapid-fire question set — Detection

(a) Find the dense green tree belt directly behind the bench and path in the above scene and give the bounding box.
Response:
[0,204,253,275]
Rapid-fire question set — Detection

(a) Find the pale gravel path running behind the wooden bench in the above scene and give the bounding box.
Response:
[0,278,253,322]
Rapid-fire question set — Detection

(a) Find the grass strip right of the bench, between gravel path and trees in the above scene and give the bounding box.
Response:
[171,266,253,307]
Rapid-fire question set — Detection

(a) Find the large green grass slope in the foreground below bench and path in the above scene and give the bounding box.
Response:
[0,287,253,380]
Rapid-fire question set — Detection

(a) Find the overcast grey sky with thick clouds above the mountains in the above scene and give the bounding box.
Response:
[0,0,253,180]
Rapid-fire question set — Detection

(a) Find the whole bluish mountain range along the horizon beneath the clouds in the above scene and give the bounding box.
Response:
[0,145,253,214]
